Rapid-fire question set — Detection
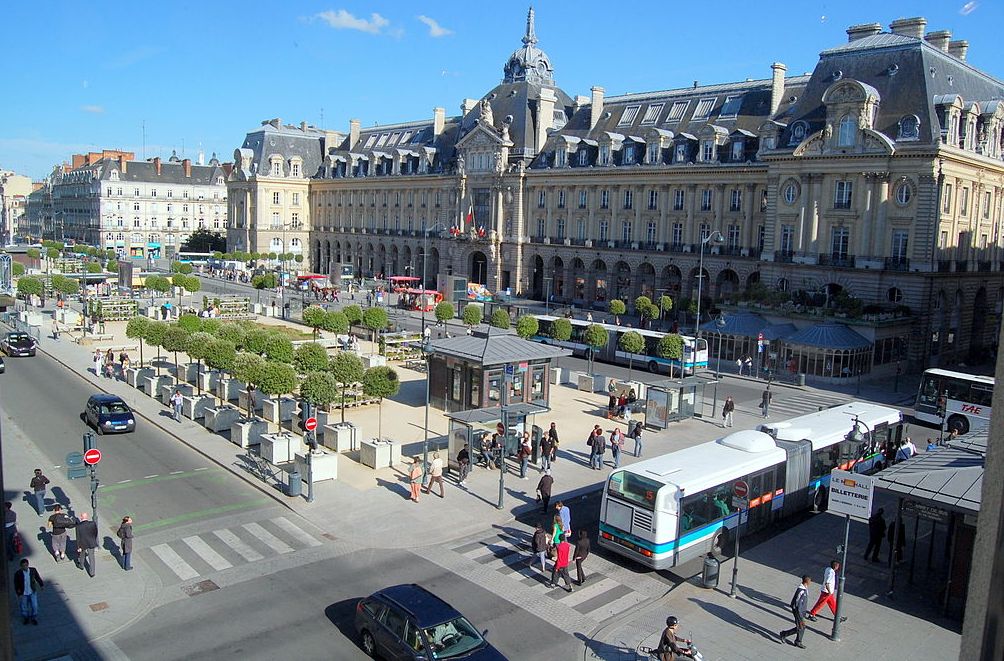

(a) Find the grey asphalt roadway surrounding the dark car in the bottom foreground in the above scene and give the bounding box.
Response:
[113,550,582,661]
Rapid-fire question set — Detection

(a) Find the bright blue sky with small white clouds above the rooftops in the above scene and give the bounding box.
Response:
[0,0,1004,179]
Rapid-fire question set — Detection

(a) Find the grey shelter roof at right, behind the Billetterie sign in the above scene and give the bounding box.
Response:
[875,429,989,513]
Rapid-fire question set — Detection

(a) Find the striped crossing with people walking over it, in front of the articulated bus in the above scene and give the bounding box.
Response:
[450,531,652,622]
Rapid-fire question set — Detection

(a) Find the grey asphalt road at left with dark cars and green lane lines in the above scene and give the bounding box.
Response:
[0,354,274,529]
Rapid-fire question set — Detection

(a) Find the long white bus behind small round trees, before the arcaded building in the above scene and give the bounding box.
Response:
[530,314,708,375]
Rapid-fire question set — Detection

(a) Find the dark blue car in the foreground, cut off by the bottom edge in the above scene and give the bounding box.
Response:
[355,584,505,661]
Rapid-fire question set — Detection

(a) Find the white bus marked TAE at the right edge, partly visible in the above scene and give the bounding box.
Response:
[914,369,994,434]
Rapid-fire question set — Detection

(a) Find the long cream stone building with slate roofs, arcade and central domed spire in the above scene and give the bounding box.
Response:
[230,10,1004,379]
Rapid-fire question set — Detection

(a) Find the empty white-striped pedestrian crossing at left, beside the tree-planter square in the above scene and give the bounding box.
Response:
[140,516,322,581]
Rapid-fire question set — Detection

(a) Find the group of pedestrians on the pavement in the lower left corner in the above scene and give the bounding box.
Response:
[4,468,134,625]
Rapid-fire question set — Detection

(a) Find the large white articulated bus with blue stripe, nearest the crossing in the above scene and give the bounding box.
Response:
[598,402,903,570]
